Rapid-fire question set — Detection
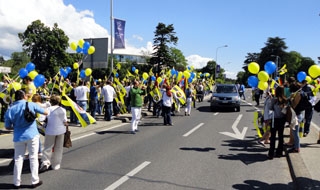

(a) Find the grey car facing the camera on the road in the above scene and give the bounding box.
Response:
[210,84,241,112]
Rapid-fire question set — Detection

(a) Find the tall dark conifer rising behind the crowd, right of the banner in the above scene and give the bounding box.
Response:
[150,23,178,74]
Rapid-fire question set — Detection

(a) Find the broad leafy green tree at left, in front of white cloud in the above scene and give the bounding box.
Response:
[18,20,73,77]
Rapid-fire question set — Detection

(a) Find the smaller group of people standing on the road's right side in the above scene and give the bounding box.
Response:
[256,77,316,159]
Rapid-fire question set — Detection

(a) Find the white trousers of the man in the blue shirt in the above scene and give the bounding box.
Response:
[13,135,40,186]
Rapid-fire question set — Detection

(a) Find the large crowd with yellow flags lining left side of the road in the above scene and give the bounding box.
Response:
[0,73,211,188]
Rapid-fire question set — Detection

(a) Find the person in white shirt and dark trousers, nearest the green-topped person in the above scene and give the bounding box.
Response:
[101,80,117,121]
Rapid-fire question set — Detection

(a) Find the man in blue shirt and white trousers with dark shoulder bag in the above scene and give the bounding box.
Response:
[5,90,48,188]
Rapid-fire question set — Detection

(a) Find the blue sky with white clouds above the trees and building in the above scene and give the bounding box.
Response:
[0,0,320,78]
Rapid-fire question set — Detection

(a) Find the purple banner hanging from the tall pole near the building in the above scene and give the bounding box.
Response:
[114,19,126,49]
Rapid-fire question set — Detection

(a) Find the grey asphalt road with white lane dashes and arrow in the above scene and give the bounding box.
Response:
[0,98,293,190]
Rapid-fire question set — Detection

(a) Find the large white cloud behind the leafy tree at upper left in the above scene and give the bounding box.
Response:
[0,0,109,57]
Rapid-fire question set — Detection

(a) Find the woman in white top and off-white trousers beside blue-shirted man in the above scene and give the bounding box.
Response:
[40,95,68,172]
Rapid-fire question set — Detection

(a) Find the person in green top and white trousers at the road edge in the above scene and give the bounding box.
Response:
[130,81,146,134]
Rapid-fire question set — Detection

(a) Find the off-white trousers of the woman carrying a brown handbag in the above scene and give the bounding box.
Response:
[41,134,64,169]
